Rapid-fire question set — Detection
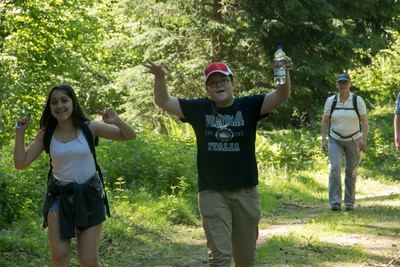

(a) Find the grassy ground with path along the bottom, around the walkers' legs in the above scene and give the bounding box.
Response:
[0,164,400,266]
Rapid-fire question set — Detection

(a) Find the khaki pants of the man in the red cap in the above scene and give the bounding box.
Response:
[198,186,261,267]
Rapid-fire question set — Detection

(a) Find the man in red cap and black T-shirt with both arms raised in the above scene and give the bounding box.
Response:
[143,57,292,267]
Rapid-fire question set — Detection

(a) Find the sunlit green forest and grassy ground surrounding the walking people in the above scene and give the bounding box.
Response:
[0,0,400,266]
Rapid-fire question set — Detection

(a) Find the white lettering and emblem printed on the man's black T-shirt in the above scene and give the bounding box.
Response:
[205,111,244,152]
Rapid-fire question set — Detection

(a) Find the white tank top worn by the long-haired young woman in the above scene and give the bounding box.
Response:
[50,131,96,184]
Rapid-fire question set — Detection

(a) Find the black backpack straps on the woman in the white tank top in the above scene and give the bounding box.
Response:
[43,123,110,218]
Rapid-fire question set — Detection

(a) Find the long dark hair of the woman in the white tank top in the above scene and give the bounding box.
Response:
[40,84,99,153]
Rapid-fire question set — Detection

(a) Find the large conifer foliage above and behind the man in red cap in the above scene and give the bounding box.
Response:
[106,0,399,129]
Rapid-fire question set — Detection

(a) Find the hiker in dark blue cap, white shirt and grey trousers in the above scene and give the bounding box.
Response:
[321,73,368,211]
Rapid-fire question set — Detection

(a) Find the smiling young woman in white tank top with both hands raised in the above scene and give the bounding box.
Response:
[14,85,136,267]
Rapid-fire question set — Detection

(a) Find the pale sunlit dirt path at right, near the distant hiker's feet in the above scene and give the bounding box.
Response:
[257,188,400,267]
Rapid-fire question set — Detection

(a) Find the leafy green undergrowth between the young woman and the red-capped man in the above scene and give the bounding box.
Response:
[97,124,197,194]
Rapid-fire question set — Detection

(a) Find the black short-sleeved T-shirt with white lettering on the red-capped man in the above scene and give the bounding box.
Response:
[179,95,268,192]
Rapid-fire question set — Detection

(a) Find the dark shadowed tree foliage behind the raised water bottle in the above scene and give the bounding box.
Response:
[244,0,399,126]
